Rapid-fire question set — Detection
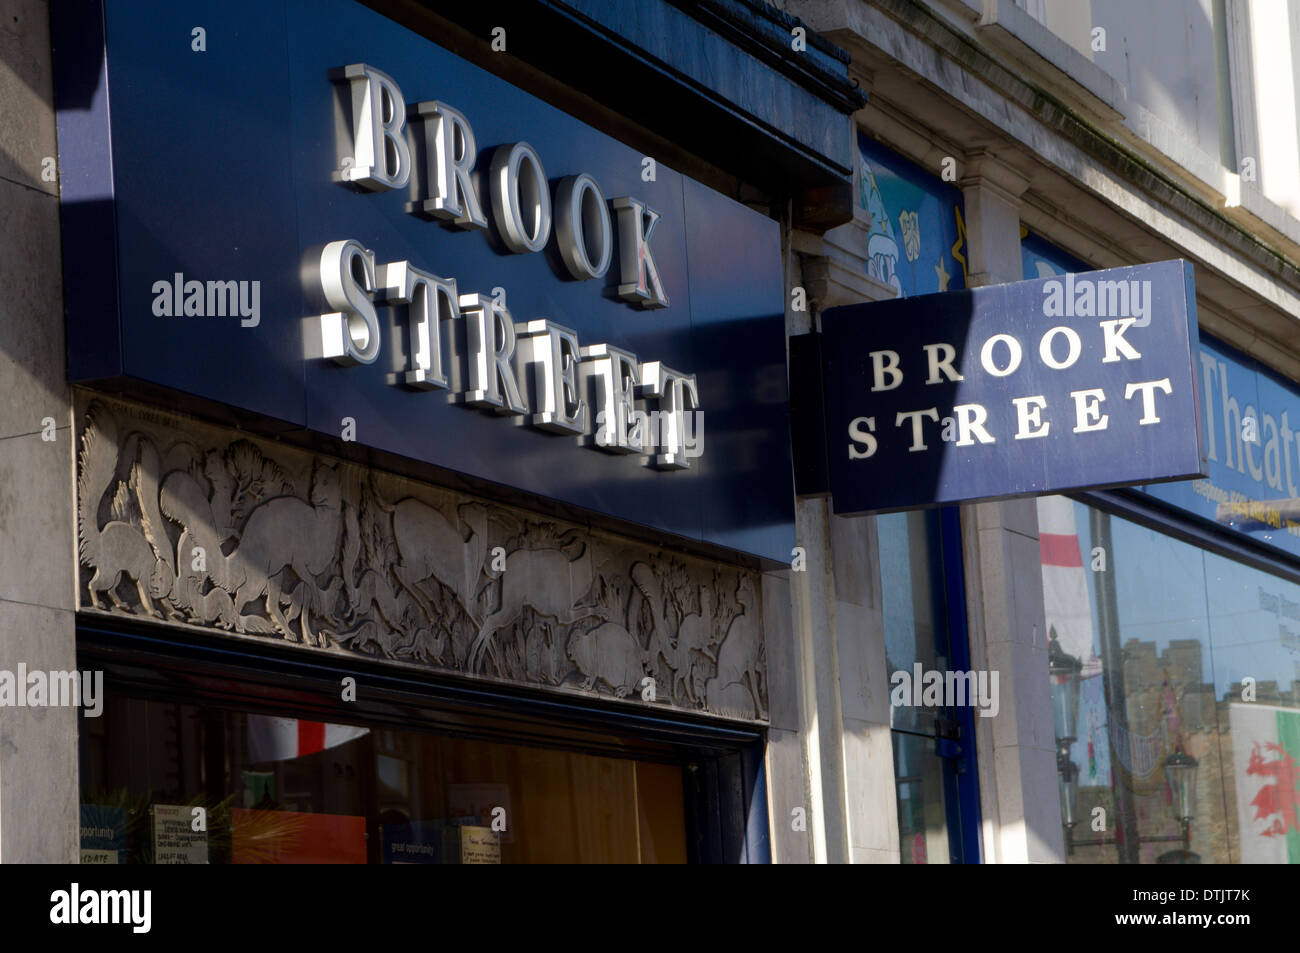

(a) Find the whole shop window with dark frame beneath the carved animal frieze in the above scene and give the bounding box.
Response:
[79,624,766,863]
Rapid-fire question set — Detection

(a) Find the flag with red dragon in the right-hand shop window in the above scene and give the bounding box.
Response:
[1229,703,1300,863]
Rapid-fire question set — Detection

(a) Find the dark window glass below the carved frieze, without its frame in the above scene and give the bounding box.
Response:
[81,694,688,863]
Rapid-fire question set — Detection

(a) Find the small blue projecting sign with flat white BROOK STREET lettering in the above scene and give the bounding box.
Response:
[822,261,1205,514]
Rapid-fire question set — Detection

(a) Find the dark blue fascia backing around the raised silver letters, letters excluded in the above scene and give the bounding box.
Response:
[56,0,793,562]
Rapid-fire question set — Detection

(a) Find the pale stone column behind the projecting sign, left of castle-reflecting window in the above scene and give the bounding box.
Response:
[959,151,1065,863]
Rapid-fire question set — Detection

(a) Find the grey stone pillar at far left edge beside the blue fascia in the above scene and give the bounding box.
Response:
[0,3,81,863]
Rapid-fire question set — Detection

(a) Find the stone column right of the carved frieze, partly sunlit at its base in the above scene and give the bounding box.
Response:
[764,120,900,863]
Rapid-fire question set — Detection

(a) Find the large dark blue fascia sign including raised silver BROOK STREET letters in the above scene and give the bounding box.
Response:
[53,0,793,560]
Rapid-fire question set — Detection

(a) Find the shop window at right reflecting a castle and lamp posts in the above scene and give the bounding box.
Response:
[1039,497,1300,863]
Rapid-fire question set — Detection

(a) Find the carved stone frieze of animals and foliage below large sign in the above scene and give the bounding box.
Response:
[77,398,767,722]
